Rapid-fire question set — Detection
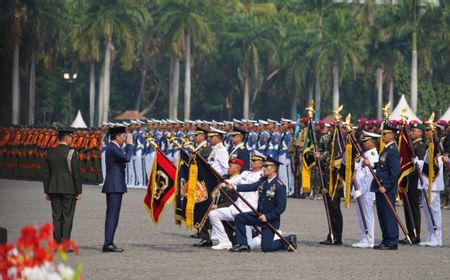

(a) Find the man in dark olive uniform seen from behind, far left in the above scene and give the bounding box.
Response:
[44,129,82,243]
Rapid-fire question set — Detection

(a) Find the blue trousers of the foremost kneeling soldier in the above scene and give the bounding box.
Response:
[234,212,288,252]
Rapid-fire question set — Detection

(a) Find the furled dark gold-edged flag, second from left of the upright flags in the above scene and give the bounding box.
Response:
[328,124,345,198]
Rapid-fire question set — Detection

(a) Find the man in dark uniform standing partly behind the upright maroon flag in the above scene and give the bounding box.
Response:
[399,122,427,244]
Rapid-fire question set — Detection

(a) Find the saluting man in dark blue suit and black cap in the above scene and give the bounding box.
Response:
[102,127,134,253]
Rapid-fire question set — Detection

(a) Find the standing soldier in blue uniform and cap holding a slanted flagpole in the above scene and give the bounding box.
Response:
[366,124,400,250]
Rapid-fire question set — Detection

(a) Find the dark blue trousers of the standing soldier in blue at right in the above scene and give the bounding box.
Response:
[375,192,398,246]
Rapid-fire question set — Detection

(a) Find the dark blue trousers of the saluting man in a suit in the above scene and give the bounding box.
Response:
[103,193,123,246]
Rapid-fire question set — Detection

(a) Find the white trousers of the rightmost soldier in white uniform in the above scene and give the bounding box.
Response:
[422,191,442,244]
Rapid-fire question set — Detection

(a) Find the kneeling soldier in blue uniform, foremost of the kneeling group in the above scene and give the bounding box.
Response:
[228,156,297,252]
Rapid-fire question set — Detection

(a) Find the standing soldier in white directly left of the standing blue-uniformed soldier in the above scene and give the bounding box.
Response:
[352,131,380,248]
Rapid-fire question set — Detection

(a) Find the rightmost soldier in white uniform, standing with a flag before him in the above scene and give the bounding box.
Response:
[414,123,448,247]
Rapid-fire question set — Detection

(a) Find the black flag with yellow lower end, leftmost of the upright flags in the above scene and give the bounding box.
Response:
[302,121,316,192]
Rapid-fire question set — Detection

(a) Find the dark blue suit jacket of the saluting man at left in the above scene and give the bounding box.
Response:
[102,141,134,193]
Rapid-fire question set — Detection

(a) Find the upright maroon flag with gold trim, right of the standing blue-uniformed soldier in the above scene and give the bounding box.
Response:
[398,126,414,192]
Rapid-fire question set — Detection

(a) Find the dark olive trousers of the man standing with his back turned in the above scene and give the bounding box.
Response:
[49,194,76,243]
